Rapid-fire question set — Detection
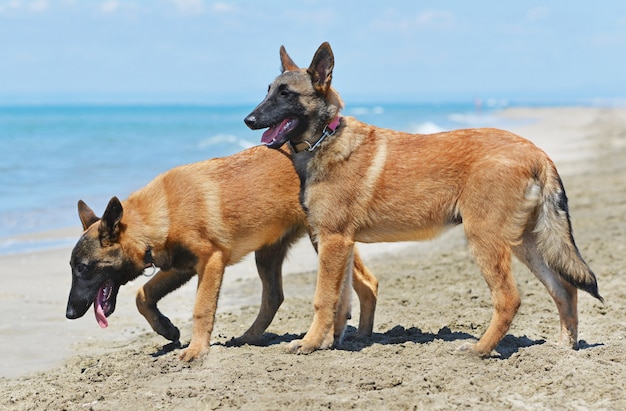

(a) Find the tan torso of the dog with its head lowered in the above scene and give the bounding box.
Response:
[123,146,305,264]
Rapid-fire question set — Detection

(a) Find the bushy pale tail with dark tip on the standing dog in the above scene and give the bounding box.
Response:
[534,160,604,301]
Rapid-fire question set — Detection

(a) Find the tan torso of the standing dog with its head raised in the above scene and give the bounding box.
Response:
[305,121,545,242]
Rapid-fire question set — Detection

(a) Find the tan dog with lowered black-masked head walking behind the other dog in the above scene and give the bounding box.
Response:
[66,147,378,361]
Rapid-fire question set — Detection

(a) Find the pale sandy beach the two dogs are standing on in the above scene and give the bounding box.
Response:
[0,108,626,410]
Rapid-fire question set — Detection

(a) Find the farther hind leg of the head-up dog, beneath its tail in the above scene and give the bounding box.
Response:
[513,233,578,349]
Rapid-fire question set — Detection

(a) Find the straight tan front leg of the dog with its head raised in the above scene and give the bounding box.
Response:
[287,234,354,354]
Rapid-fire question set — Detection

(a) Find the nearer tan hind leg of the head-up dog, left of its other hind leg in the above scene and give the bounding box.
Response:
[459,229,521,356]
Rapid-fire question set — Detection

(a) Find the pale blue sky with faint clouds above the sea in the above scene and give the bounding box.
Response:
[0,0,626,104]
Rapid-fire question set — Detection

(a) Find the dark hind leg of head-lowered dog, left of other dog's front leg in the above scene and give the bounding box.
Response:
[231,230,303,345]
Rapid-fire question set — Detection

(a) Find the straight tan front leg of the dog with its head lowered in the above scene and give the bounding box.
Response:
[180,250,226,361]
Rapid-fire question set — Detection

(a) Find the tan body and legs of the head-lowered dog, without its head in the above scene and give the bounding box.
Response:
[78,147,377,361]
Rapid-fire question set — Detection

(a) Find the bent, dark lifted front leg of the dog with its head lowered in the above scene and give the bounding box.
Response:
[135,270,195,342]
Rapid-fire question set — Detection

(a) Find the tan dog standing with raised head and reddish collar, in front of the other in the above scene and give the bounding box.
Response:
[245,43,602,356]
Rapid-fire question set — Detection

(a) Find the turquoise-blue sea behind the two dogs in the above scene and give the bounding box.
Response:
[0,103,506,254]
